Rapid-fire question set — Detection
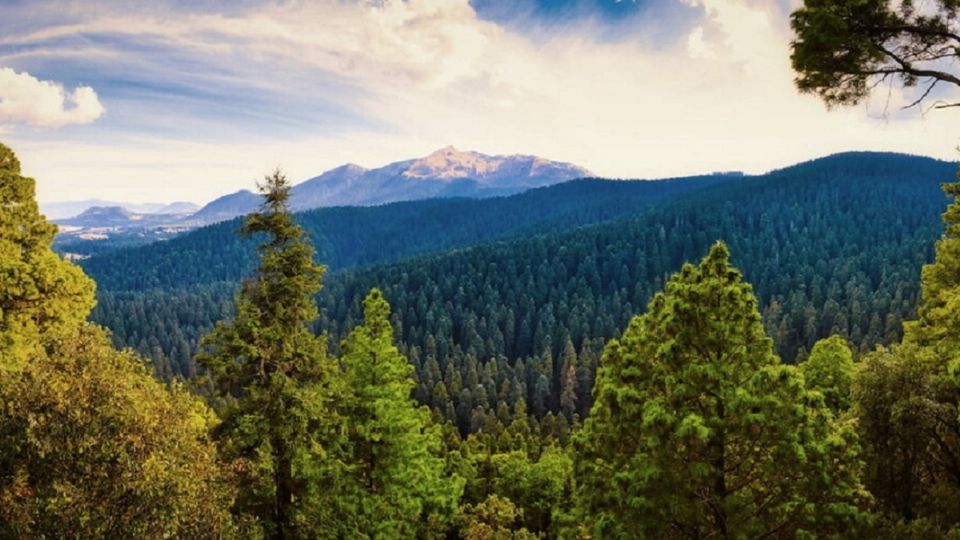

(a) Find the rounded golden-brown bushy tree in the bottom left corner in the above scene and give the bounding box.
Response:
[0,326,233,539]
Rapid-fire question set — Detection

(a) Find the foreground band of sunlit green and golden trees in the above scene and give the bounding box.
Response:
[0,138,960,540]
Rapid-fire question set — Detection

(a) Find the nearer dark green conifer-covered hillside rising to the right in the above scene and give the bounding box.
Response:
[93,153,955,432]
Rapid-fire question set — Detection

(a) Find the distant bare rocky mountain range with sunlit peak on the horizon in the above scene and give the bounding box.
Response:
[50,146,593,247]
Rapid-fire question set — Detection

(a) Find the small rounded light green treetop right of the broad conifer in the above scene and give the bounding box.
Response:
[800,336,854,416]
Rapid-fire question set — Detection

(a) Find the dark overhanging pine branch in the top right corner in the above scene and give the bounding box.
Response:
[791,0,960,107]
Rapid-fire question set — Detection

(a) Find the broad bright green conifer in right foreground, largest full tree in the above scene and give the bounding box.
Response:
[575,243,864,538]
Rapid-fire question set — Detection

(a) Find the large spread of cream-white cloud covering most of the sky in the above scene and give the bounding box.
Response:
[0,0,957,200]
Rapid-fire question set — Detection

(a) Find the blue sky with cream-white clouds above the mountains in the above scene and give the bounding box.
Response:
[0,0,960,203]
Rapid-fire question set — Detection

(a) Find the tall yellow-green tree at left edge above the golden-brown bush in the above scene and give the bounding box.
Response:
[0,144,94,369]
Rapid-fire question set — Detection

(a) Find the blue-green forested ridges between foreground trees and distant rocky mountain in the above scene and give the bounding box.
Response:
[82,152,957,380]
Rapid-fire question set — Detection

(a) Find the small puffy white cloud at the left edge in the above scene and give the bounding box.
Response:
[0,67,105,128]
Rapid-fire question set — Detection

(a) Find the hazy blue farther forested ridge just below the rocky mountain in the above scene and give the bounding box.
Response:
[82,176,728,291]
